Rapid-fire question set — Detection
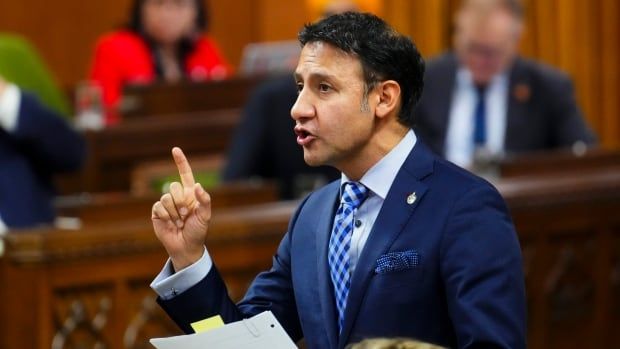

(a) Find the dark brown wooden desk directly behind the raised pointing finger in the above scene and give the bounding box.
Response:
[59,109,240,194]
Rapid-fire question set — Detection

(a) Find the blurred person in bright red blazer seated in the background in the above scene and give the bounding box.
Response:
[89,0,232,125]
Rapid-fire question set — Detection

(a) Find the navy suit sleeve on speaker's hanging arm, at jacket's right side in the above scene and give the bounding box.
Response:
[441,185,526,349]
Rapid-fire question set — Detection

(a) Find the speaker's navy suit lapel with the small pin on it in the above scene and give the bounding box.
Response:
[338,139,434,348]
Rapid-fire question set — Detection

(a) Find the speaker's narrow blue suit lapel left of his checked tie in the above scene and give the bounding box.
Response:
[316,181,340,348]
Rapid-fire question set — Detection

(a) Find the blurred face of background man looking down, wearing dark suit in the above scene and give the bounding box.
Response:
[454,9,520,85]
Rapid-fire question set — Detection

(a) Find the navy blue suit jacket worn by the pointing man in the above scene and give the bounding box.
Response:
[159,140,526,348]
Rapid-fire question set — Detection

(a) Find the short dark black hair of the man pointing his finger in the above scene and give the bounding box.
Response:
[299,12,424,127]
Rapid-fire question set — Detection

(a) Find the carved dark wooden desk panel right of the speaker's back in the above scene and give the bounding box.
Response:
[498,166,620,348]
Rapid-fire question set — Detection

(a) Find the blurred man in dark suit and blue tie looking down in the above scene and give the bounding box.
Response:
[415,0,596,168]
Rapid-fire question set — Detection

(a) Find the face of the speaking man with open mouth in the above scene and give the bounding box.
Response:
[291,42,376,172]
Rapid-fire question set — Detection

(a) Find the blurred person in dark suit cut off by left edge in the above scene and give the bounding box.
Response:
[0,76,86,230]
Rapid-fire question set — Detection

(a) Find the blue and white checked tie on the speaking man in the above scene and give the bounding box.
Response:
[328,182,368,331]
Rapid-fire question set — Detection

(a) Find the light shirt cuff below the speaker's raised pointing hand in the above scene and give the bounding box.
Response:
[151,247,213,300]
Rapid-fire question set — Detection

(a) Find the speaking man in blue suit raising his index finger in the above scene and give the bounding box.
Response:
[152,13,526,348]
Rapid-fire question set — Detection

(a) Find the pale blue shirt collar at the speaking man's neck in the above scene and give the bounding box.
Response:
[340,130,417,200]
